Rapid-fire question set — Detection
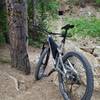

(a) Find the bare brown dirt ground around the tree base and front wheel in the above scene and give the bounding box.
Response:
[0,37,100,100]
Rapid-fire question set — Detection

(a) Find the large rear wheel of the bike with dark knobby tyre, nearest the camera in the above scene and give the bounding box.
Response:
[58,52,94,100]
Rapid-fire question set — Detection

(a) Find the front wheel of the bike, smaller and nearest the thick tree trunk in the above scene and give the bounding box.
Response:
[35,48,50,80]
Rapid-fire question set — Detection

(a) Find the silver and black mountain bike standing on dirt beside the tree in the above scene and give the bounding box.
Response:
[35,24,94,100]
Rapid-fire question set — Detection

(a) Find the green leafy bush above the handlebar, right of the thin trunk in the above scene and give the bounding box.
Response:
[36,0,59,29]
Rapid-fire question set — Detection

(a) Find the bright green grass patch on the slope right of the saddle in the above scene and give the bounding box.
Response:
[66,17,100,37]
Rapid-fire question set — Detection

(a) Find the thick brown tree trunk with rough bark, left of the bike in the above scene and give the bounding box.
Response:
[6,0,30,74]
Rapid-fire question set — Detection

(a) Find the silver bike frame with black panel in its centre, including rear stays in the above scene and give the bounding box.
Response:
[42,35,76,77]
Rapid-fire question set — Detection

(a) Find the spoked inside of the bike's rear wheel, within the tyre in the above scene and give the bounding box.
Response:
[63,57,87,100]
